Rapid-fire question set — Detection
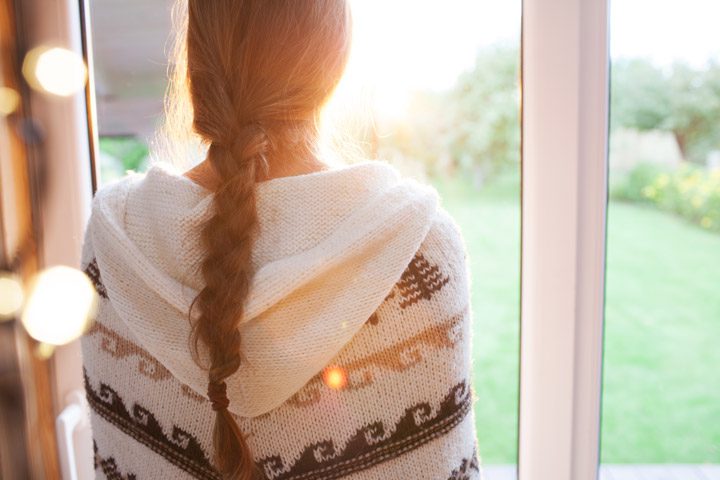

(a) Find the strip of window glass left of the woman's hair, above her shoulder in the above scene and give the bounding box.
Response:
[90,0,166,183]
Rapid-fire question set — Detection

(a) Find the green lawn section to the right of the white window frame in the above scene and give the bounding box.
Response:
[602,202,720,463]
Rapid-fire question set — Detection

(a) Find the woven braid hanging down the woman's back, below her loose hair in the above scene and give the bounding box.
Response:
[195,127,267,480]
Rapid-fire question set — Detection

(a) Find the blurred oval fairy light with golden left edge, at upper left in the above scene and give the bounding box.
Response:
[22,47,87,97]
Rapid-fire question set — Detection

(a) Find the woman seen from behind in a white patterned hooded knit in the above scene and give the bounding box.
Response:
[82,0,480,480]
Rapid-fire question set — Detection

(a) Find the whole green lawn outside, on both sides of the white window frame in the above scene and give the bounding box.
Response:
[435,171,720,464]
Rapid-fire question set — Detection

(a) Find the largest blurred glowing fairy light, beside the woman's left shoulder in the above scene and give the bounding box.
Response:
[22,266,97,345]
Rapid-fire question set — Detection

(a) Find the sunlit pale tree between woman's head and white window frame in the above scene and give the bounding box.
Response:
[380,45,520,179]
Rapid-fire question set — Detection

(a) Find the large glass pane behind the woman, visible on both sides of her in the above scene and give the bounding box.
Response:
[91,0,521,480]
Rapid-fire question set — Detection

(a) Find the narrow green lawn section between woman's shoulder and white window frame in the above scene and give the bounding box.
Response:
[435,171,520,463]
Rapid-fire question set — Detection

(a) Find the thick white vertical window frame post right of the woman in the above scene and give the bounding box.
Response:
[518,0,609,480]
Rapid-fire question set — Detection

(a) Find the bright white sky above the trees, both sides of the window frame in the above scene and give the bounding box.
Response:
[347,0,720,111]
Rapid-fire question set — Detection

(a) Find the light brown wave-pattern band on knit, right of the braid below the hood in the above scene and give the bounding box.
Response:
[288,310,466,407]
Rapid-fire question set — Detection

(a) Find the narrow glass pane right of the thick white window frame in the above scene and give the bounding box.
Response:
[601,0,720,479]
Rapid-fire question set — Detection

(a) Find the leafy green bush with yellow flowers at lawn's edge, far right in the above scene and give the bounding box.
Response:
[611,163,720,232]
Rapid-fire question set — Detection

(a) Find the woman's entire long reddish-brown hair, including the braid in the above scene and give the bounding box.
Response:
[180,0,351,480]
